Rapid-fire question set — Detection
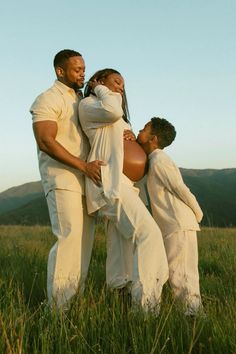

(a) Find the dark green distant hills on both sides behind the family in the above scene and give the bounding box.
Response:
[0,168,236,227]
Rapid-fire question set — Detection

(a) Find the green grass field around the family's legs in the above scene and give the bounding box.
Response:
[0,226,236,354]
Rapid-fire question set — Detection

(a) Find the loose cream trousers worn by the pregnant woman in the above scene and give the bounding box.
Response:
[101,180,168,308]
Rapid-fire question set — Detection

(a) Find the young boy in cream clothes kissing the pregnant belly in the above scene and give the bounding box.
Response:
[137,117,203,315]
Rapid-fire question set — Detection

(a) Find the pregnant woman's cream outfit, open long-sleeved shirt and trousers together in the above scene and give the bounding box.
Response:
[79,85,168,308]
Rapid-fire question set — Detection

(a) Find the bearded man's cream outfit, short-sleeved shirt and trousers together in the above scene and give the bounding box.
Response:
[30,80,95,306]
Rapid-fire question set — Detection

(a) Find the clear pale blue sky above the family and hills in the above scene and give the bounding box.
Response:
[0,0,236,192]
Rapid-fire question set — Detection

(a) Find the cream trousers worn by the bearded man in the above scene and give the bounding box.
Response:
[47,189,95,307]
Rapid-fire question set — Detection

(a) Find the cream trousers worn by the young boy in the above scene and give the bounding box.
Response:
[164,231,201,312]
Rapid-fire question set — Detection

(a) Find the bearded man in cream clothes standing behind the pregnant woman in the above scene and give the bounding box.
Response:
[30,49,103,307]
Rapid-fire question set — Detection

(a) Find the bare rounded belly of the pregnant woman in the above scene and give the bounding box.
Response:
[123,140,147,182]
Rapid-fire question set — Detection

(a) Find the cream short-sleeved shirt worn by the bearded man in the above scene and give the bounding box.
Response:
[30,80,89,194]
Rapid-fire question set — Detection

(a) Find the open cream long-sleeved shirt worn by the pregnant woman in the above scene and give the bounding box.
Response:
[79,85,130,214]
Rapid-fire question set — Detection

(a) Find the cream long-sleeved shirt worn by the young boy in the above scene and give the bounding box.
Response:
[147,149,203,236]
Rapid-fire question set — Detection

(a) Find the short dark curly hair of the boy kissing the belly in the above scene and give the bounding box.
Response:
[151,117,176,149]
